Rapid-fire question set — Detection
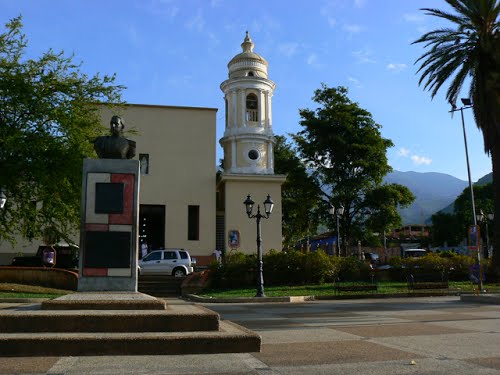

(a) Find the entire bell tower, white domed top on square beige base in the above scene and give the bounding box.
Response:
[217,31,286,253]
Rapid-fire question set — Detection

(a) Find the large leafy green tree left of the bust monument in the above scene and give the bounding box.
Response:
[0,17,123,243]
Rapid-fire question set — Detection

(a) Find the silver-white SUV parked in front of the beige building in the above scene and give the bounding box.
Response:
[139,249,196,277]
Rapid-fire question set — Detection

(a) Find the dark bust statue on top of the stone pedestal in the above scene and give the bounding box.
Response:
[94,116,136,159]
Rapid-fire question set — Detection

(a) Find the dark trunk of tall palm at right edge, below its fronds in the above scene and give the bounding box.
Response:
[491,138,500,280]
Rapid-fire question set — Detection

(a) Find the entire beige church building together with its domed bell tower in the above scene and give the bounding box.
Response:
[0,33,285,264]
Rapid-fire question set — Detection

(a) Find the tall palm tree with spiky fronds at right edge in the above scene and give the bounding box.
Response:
[413,0,500,277]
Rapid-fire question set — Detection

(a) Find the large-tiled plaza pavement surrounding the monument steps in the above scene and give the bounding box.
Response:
[0,297,500,375]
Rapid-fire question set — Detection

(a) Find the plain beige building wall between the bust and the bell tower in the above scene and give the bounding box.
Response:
[102,105,217,256]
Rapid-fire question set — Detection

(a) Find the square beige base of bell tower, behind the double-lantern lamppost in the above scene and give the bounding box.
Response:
[220,175,285,254]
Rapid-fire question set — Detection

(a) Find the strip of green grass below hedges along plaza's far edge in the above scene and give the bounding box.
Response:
[199,281,500,298]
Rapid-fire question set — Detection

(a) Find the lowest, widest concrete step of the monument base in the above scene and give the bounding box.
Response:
[0,321,261,357]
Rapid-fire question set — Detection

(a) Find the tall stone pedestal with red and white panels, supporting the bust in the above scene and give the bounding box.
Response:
[78,159,140,292]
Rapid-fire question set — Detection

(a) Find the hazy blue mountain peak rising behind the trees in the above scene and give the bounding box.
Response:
[384,171,468,225]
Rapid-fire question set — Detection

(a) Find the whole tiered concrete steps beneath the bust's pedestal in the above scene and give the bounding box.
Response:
[0,292,261,357]
